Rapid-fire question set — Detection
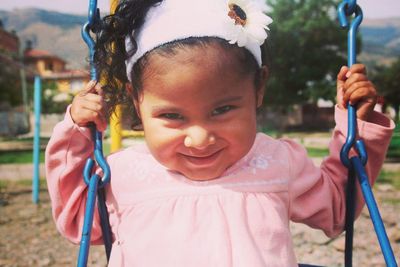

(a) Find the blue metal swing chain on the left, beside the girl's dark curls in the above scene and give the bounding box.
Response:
[77,0,112,267]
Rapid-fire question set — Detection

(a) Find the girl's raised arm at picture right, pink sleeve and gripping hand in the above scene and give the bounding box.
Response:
[287,64,394,236]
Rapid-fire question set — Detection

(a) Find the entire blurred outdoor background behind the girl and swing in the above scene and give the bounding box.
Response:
[0,0,400,266]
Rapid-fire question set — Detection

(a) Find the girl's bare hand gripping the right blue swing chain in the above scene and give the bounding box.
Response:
[337,64,377,121]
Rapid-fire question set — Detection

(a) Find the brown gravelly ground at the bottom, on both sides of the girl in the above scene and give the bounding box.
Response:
[0,183,400,267]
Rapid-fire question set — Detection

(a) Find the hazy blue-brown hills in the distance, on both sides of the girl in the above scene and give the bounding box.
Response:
[0,9,400,68]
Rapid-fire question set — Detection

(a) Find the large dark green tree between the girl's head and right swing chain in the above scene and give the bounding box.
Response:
[265,0,347,107]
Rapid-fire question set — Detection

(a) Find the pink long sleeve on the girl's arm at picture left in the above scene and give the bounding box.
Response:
[45,108,101,244]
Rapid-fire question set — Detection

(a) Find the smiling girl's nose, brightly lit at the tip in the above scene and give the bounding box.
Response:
[184,126,215,149]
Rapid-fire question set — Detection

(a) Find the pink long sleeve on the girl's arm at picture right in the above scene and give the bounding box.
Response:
[287,105,394,236]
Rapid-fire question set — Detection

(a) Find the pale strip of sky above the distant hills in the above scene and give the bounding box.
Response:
[0,0,400,19]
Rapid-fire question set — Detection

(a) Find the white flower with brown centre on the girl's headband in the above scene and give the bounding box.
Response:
[228,0,272,47]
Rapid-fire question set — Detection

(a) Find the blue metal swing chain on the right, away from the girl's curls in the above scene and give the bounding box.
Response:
[338,0,397,267]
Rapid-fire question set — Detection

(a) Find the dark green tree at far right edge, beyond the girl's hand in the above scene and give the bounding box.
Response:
[373,57,400,122]
